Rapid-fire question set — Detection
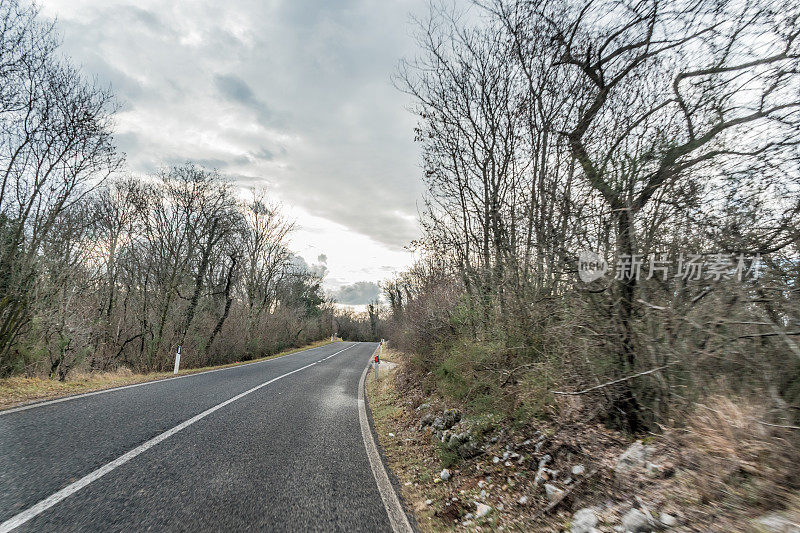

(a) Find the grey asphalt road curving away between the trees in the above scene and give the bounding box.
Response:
[0,342,390,531]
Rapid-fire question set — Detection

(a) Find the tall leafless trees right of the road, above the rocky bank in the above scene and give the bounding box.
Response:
[392,0,800,431]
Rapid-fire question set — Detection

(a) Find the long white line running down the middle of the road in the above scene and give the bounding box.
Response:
[0,344,355,533]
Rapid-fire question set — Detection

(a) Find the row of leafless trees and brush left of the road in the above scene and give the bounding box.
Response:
[0,0,354,382]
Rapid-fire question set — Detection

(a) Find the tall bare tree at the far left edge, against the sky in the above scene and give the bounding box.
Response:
[0,0,121,372]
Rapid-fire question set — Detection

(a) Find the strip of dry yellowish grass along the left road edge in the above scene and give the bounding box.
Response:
[0,340,338,409]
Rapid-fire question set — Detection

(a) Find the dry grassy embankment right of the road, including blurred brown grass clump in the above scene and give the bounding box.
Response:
[367,344,800,533]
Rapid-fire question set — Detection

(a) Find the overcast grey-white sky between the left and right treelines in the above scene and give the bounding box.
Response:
[40,0,427,303]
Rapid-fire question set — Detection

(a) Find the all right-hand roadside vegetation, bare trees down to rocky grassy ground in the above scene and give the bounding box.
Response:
[384,0,800,532]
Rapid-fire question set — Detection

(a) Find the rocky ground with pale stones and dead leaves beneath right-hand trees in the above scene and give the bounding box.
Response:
[367,353,800,533]
